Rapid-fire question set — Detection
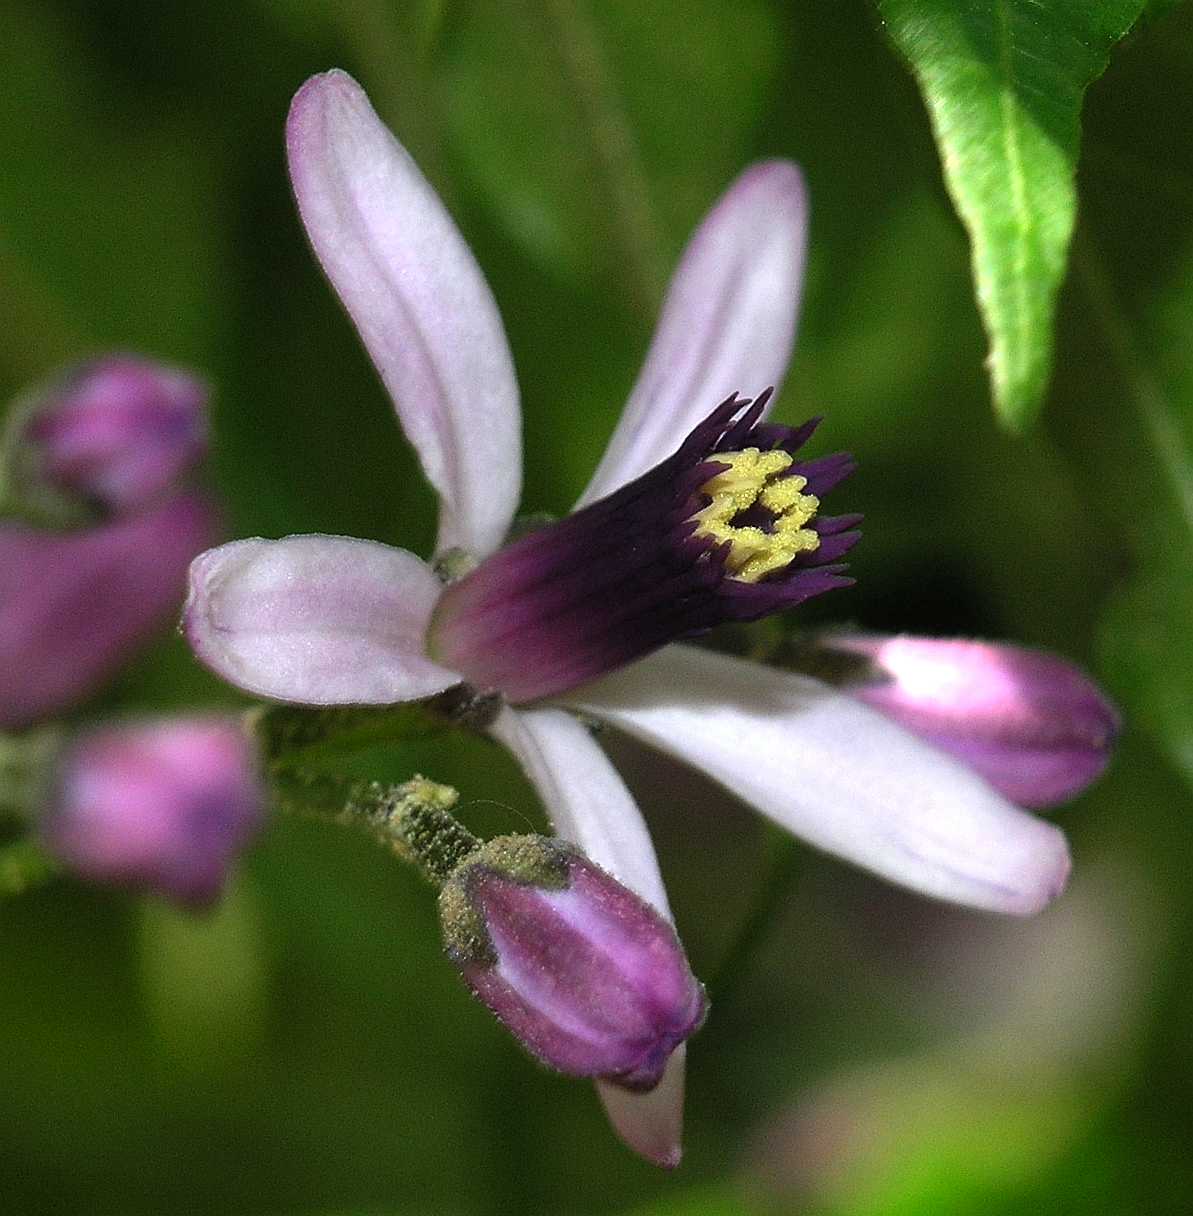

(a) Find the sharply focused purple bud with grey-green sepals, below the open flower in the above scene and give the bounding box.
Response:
[439,837,708,1091]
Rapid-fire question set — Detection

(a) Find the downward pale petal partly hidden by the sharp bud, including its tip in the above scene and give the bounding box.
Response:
[490,709,685,1169]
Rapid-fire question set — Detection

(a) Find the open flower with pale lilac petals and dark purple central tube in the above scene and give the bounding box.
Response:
[185,72,1089,1165]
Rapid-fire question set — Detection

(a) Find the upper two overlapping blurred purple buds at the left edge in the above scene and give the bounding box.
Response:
[0,355,219,730]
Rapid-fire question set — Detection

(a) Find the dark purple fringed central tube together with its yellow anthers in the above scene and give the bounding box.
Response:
[427,390,860,705]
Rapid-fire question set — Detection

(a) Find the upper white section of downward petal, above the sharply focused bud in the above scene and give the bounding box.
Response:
[490,708,671,918]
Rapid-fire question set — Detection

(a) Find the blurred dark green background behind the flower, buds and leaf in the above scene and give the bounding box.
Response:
[0,0,1193,1216]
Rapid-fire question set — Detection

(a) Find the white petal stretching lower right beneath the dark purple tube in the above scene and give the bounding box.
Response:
[569,646,1069,916]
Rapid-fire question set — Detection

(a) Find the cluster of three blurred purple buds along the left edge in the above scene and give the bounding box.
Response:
[0,355,263,907]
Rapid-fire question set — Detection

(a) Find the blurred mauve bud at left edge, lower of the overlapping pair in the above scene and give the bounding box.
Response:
[0,495,218,728]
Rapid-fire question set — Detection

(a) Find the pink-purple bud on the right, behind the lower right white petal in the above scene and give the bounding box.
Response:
[826,636,1119,806]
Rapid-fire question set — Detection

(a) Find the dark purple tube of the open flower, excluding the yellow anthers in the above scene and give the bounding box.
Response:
[431,394,857,703]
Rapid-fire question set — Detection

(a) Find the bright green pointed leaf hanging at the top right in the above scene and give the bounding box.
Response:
[878,0,1143,432]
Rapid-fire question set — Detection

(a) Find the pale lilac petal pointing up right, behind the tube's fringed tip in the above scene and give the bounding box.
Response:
[578,161,807,506]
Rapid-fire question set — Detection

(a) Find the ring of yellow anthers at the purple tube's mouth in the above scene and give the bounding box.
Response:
[692,447,820,582]
